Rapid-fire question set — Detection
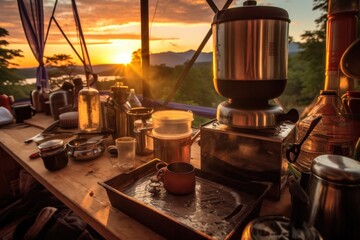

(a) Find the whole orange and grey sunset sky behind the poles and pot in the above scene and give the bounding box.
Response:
[0,0,320,67]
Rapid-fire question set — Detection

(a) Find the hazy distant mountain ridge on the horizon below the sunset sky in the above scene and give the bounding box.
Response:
[16,42,301,78]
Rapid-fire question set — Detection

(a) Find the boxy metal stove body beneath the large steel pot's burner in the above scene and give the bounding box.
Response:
[200,120,295,199]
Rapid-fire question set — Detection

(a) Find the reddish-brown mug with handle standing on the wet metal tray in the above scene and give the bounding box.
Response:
[156,162,195,195]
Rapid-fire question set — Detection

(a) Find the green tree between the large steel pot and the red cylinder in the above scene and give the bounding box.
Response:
[281,0,328,109]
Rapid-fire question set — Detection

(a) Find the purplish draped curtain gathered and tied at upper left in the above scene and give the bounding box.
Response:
[17,0,49,88]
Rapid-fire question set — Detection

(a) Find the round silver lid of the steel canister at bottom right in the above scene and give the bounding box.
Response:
[311,154,360,184]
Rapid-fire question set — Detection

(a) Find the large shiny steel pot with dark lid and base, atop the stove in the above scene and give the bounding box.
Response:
[212,1,290,99]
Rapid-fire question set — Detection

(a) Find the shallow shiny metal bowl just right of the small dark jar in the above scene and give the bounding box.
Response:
[67,138,105,160]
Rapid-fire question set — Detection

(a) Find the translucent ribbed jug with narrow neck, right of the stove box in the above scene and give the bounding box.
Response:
[295,90,353,172]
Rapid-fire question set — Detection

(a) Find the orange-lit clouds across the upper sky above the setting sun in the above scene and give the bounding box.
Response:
[0,0,225,43]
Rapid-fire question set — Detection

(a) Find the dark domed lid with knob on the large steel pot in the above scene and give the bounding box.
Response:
[212,1,290,24]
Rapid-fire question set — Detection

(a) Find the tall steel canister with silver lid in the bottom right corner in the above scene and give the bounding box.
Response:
[307,154,360,240]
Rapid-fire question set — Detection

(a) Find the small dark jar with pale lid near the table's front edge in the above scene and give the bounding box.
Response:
[38,139,68,171]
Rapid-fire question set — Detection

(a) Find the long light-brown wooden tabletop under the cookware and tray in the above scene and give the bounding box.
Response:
[0,114,290,239]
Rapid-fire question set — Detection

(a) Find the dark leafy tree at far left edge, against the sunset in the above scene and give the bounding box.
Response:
[0,27,24,85]
